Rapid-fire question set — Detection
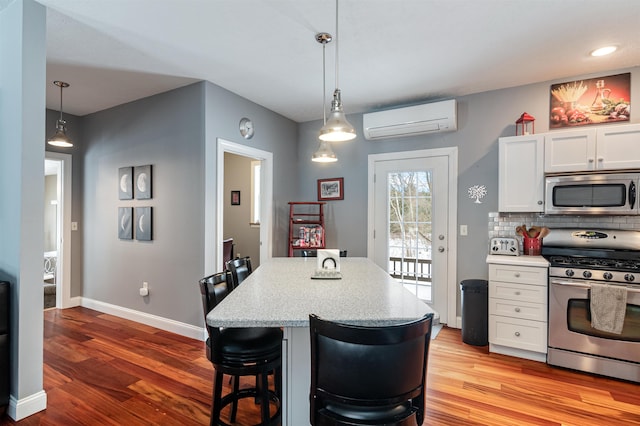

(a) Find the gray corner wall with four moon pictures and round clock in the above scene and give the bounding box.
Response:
[72,82,297,326]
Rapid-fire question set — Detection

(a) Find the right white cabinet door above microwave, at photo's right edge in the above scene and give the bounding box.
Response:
[596,124,640,170]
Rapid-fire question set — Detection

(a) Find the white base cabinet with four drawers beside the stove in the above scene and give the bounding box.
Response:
[489,263,548,362]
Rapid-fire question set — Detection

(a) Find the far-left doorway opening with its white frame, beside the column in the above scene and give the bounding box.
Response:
[43,152,71,308]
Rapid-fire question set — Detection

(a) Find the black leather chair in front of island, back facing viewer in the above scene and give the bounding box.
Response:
[309,314,433,426]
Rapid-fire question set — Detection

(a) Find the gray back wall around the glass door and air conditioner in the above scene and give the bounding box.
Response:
[297,67,640,288]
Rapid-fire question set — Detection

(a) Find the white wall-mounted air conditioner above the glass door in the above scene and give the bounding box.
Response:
[362,99,458,140]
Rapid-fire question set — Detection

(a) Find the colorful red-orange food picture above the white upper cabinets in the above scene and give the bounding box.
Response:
[549,73,631,129]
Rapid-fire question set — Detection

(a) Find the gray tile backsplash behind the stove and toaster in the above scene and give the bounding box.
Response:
[489,212,640,238]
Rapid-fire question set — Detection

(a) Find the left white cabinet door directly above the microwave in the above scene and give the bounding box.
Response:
[544,129,597,173]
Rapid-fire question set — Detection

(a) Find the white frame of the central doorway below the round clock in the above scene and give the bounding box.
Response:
[204,138,273,276]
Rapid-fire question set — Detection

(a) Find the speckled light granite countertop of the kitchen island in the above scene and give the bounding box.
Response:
[207,257,433,327]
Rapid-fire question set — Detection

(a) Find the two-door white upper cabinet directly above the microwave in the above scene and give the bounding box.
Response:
[544,124,640,173]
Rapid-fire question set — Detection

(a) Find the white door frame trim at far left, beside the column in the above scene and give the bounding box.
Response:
[43,151,72,309]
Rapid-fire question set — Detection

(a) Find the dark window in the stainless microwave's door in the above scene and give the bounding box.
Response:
[553,183,627,207]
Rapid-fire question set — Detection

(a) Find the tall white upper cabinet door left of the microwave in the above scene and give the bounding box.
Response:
[498,135,544,212]
